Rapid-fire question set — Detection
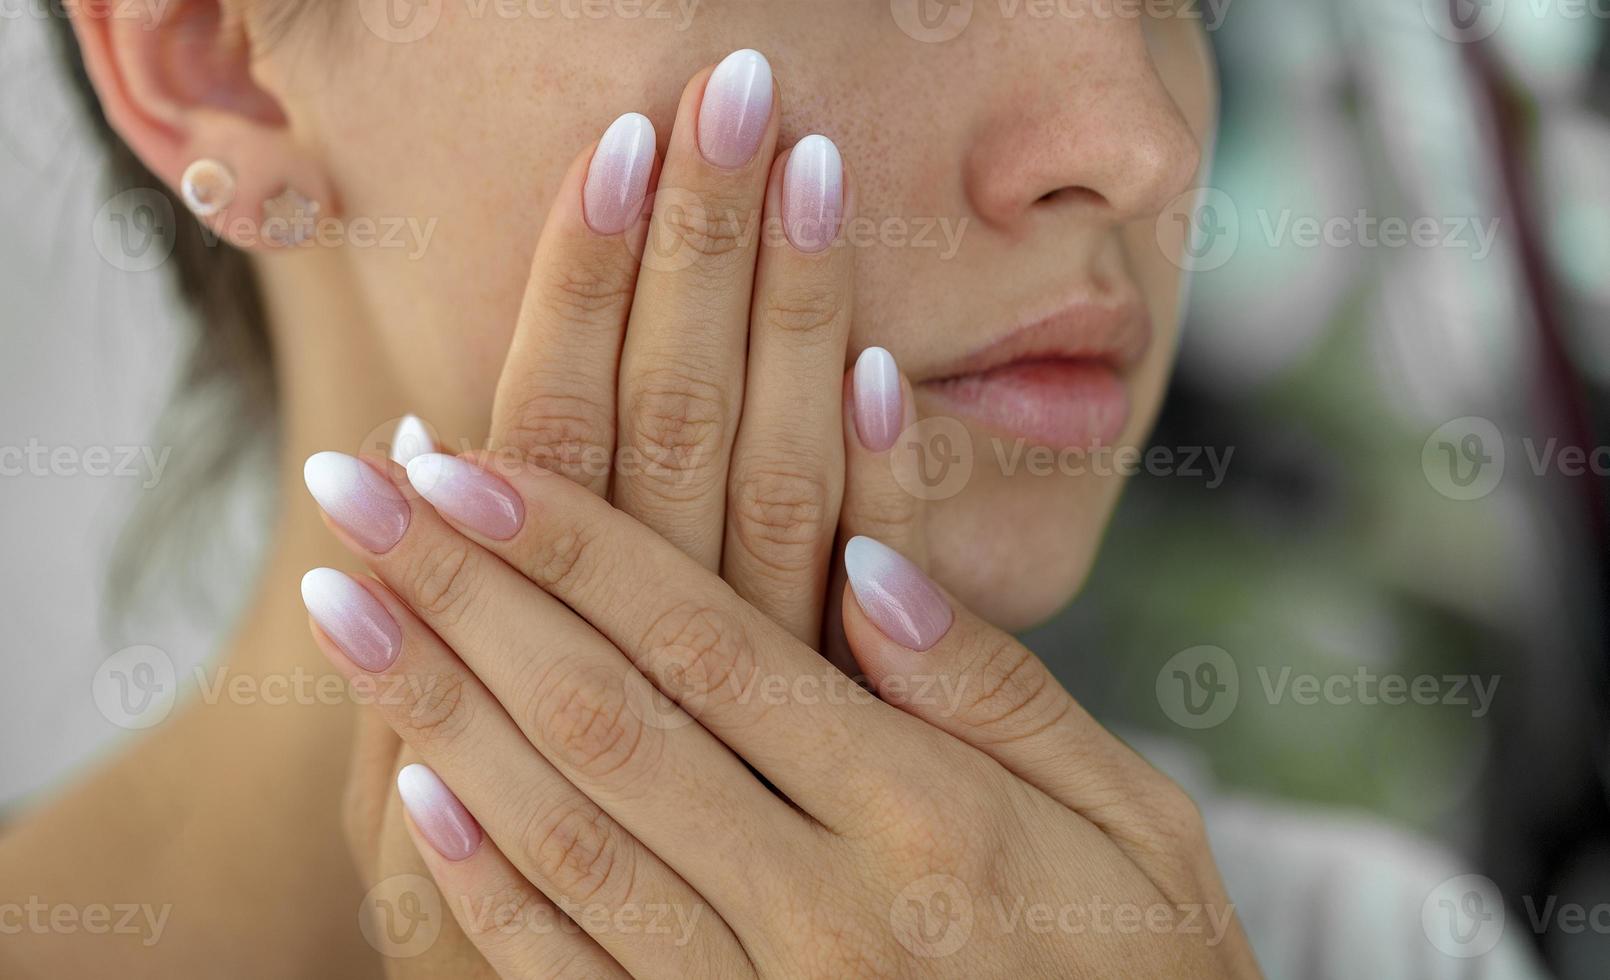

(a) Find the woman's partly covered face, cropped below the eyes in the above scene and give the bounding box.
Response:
[270,0,1214,628]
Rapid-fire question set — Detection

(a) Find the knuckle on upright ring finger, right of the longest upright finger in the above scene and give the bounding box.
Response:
[728,465,831,574]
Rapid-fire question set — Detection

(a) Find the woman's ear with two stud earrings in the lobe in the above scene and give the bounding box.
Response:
[66,0,335,249]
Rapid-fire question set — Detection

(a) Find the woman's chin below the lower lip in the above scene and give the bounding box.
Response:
[927,453,1124,632]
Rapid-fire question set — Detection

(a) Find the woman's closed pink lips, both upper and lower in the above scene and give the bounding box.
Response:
[919,294,1151,449]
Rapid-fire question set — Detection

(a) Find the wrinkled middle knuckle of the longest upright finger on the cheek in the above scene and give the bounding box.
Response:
[625,369,731,494]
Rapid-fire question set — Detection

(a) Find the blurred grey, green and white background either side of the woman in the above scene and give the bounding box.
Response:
[0,0,1610,978]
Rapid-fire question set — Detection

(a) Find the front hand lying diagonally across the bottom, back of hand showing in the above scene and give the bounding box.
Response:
[309,455,1256,977]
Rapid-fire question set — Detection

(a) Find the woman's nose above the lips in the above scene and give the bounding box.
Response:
[966,24,1201,230]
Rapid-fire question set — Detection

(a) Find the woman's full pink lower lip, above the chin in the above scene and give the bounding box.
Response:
[923,359,1129,449]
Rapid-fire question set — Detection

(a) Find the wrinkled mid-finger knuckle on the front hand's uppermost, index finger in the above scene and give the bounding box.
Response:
[639,603,760,706]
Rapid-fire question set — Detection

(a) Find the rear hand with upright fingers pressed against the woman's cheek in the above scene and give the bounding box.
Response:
[326,53,910,975]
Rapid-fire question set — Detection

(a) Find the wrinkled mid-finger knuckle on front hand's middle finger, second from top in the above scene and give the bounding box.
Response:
[536,666,658,782]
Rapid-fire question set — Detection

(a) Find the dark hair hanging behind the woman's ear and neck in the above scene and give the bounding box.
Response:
[48,0,277,623]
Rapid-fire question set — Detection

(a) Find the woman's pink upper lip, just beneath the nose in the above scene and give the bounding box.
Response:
[929,293,1151,381]
